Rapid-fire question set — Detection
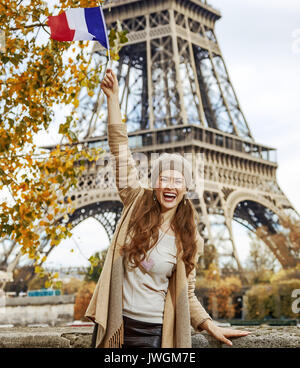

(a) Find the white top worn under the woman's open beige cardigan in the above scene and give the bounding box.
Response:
[123,230,177,323]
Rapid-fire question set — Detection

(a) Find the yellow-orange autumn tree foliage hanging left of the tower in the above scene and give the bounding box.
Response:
[0,0,126,286]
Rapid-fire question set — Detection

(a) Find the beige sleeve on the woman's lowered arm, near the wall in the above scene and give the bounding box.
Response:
[188,232,212,332]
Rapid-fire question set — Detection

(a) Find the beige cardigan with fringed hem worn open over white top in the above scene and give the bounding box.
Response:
[85,123,211,348]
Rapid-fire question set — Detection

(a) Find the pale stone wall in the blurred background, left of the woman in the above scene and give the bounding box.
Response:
[0,295,75,326]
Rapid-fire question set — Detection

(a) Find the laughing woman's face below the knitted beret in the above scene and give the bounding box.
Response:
[154,170,186,212]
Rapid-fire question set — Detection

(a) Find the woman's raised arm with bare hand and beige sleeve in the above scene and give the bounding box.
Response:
[101,69,141,205]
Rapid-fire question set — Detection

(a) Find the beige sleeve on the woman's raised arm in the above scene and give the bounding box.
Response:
[107,123,142,205]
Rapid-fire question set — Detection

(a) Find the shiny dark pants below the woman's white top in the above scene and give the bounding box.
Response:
[122,316,162,349]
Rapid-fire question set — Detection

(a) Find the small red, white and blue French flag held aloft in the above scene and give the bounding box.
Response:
[48,6,109,49]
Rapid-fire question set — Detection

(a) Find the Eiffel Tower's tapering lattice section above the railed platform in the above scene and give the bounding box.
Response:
[99,0,253,140]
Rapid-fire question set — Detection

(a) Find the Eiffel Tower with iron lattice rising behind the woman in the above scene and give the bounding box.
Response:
[41,0,299,273]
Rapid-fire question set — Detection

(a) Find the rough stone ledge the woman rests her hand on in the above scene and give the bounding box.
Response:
[0,326,300,348]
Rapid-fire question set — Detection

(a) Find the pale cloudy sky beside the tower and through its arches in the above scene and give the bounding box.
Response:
[45,0,300,266]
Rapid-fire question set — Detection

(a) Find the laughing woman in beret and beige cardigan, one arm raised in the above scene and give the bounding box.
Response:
[85,69,249,348]
